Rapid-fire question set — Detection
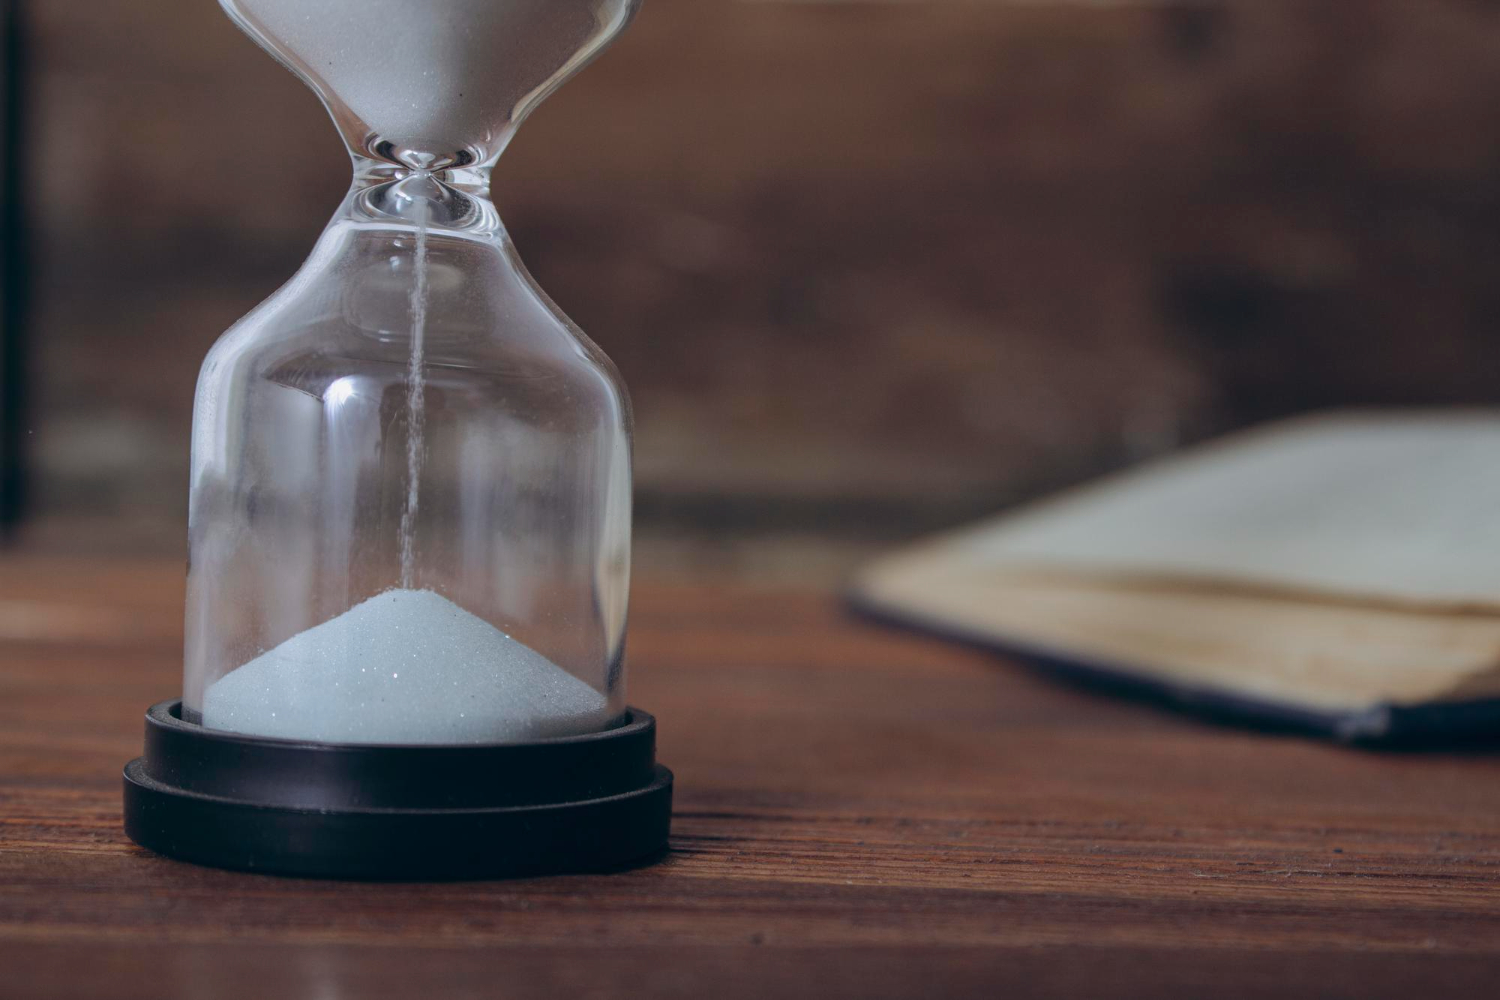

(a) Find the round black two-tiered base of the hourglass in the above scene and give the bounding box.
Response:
[125,702,672,879]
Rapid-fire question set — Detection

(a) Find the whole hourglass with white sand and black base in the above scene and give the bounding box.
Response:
[125,0,672,877]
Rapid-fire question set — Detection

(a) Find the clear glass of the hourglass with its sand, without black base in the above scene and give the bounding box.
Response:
[183,0,636,744]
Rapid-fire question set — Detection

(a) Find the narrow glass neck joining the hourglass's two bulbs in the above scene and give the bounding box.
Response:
[345,156,501,237]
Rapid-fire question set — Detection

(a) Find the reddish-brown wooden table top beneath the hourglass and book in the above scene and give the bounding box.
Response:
[0,556,1500,1000]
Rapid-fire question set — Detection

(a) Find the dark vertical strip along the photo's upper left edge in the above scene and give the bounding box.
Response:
[0,0,30,537]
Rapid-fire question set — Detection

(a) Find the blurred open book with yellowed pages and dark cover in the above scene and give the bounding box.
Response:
[854,411,1500,739]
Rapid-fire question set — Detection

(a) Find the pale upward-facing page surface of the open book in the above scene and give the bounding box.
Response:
[926,411,1500,610]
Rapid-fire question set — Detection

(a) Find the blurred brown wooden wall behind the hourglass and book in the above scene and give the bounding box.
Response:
[8,0,1500,576]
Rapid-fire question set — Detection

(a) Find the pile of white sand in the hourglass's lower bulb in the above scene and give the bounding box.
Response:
[203,589,611,744]
